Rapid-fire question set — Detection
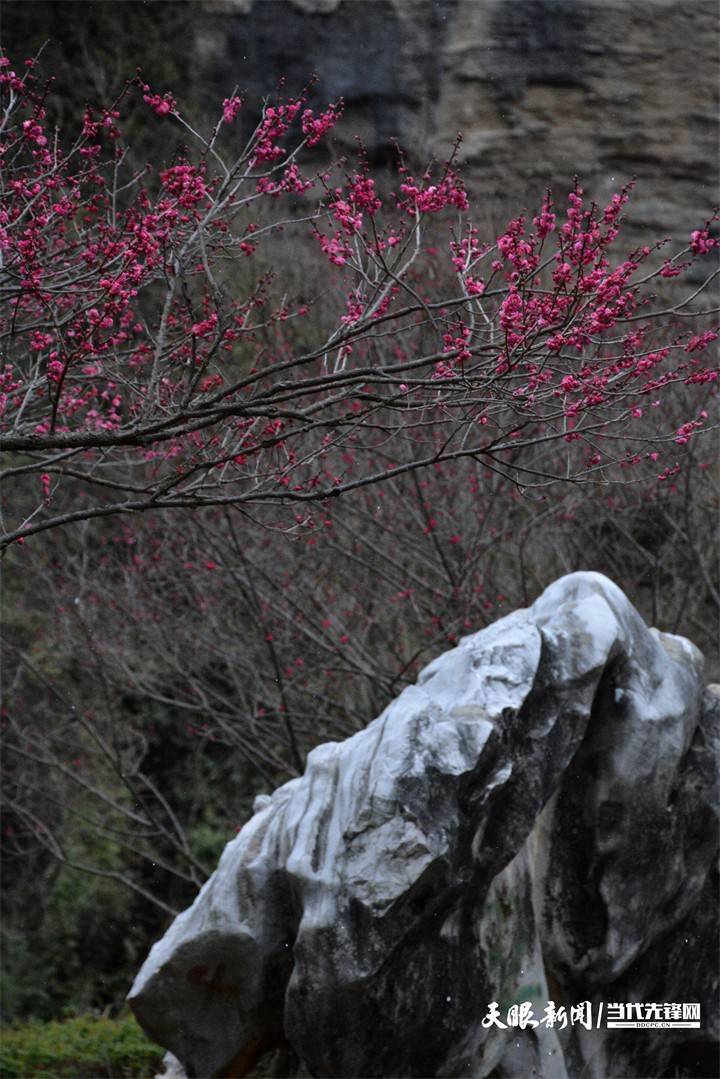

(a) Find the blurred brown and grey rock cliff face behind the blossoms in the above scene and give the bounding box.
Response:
[195,0,720,242]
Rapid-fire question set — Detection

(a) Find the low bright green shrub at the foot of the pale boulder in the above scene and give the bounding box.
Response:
[0,1015,163,1079]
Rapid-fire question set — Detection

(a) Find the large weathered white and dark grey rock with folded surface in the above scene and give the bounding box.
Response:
[130,573,720,1079]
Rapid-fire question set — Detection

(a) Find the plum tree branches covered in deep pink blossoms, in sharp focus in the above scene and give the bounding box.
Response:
[0,57,718,547]
